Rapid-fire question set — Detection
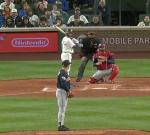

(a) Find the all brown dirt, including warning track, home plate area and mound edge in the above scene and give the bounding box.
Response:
[0,52,150,135]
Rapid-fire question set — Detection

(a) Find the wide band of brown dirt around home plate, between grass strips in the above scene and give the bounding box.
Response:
[0,78,150,98]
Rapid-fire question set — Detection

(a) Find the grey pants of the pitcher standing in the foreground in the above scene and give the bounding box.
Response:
[56,89,68,125]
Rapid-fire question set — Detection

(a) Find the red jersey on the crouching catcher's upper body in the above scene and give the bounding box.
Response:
[93,52,114,70]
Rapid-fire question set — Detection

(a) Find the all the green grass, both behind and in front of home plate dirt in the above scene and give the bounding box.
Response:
[0,60,150,132]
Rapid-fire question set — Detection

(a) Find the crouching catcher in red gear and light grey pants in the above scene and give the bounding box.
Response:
[89,44,119,83]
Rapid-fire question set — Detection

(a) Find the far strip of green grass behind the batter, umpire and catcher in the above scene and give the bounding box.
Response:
[0,60,150,80]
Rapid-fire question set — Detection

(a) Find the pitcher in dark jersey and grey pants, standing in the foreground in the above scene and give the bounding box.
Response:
[56,60,71,131]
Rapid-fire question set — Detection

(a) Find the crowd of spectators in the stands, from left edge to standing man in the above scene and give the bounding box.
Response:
[0,0,111,28]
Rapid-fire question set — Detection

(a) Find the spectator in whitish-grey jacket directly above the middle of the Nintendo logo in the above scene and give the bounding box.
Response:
[27,9,39,26]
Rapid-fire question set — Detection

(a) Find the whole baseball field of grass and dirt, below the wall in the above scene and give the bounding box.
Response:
[0,54,150,135]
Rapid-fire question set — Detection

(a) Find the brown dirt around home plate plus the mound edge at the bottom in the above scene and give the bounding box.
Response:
[0,78,150,135]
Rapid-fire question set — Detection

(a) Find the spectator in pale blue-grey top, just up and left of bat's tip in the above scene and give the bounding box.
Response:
[45,10,56,26]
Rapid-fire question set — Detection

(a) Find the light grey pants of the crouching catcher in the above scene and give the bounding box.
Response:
[92,68,112,80]
